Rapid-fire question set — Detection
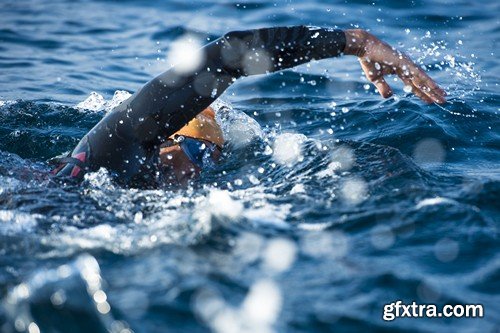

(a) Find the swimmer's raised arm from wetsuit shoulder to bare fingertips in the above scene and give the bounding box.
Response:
[57,26,444,177]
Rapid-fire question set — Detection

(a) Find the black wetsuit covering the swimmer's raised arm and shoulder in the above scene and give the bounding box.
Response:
[54,26,345,182]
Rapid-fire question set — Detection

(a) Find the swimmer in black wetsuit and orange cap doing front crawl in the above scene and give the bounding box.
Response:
[52,26,446,185]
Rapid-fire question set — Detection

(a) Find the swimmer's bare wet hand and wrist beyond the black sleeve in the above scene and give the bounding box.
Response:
[344,29,446,104]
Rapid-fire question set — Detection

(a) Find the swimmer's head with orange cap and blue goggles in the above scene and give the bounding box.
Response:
[160,108,224,185]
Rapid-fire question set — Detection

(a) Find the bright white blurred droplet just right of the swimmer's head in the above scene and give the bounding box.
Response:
[273,133,306,167]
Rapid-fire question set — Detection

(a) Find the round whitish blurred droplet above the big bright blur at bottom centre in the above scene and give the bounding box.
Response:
[263,238,297,273]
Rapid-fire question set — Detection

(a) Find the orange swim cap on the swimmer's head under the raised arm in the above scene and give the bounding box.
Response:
[170,107,224,147]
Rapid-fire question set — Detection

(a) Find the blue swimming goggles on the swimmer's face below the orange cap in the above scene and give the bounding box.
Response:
[167,135,221,169]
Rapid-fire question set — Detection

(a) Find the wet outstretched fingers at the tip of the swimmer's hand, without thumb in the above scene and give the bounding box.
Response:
[398,62,446,104]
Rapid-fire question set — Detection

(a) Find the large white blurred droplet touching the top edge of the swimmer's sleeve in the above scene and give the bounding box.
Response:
[167,34,205,75]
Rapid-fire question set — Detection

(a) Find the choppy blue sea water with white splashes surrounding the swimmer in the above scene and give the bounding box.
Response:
[0,0,500,332]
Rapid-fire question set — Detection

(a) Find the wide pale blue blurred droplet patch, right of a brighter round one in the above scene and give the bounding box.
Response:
[300,230,349,259]
